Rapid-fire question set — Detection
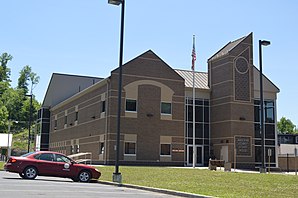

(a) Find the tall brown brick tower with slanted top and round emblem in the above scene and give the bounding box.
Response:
[208,33,255,168]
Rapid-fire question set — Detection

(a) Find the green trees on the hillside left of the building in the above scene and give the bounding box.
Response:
[0,53,40,148]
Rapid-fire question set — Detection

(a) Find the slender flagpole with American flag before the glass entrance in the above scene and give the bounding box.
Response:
[192,35,197,168]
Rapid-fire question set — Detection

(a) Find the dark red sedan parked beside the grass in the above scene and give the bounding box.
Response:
[4,151,101,182]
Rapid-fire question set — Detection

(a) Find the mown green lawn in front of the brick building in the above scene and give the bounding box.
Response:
[98,166,298,197]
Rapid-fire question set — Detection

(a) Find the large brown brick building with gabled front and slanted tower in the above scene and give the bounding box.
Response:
[38,34,279,168]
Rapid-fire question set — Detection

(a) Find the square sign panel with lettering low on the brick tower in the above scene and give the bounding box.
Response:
[235,136,251,156]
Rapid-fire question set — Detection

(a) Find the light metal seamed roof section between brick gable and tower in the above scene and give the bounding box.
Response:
[175,69,210,90]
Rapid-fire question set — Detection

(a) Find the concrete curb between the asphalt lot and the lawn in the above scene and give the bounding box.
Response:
[98,180,211,198]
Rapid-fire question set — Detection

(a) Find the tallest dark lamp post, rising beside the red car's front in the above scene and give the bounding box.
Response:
[108,0,125,183]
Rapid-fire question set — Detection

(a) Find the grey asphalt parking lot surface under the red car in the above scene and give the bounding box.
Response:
[0,171,179,198]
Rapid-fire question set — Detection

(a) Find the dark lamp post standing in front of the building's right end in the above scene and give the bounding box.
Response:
[259,40,270,173]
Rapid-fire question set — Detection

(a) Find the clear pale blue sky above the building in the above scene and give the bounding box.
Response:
[0,0,298,126]
